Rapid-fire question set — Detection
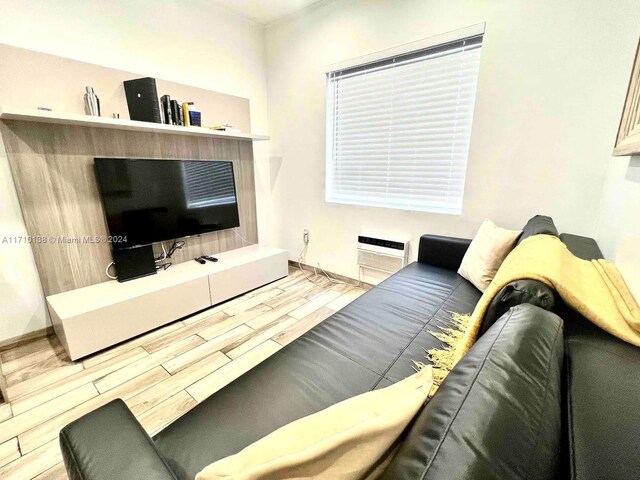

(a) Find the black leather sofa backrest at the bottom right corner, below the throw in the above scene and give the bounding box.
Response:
[563,312,640,480]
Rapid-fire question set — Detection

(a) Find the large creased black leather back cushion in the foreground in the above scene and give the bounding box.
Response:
[380,304,564,480]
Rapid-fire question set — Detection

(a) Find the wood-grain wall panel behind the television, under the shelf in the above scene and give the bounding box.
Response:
[0,121,258,296]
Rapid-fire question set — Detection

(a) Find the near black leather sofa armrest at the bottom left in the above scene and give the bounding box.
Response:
[60,399,177,480]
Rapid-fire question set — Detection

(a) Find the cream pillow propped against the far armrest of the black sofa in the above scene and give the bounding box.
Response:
[458,219,522,292]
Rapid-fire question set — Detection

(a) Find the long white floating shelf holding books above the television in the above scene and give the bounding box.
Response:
[0,107,269,142]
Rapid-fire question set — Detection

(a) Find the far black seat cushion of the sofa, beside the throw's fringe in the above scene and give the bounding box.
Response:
[307,263,479,378]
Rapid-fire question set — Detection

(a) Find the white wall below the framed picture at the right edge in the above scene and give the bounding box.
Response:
[596,156,640,303]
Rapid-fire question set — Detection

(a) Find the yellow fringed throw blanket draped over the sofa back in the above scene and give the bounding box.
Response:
[438,235,640,374]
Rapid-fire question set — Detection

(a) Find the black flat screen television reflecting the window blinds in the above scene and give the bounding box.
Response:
[95,158,240,248]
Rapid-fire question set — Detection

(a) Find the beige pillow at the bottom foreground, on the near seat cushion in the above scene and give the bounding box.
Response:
[196,366,433,480]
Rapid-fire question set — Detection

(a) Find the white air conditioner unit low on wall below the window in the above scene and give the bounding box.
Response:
[358,233,409,273]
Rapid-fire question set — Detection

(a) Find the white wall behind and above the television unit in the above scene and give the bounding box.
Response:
[0,0,272,341]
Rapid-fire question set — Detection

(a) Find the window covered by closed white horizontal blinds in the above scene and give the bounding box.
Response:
[326,35,482,214]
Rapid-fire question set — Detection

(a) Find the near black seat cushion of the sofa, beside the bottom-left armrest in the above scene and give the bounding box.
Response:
[154,337,380,480]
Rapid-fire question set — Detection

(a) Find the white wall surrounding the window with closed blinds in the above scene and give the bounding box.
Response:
[266,0,640,284]
